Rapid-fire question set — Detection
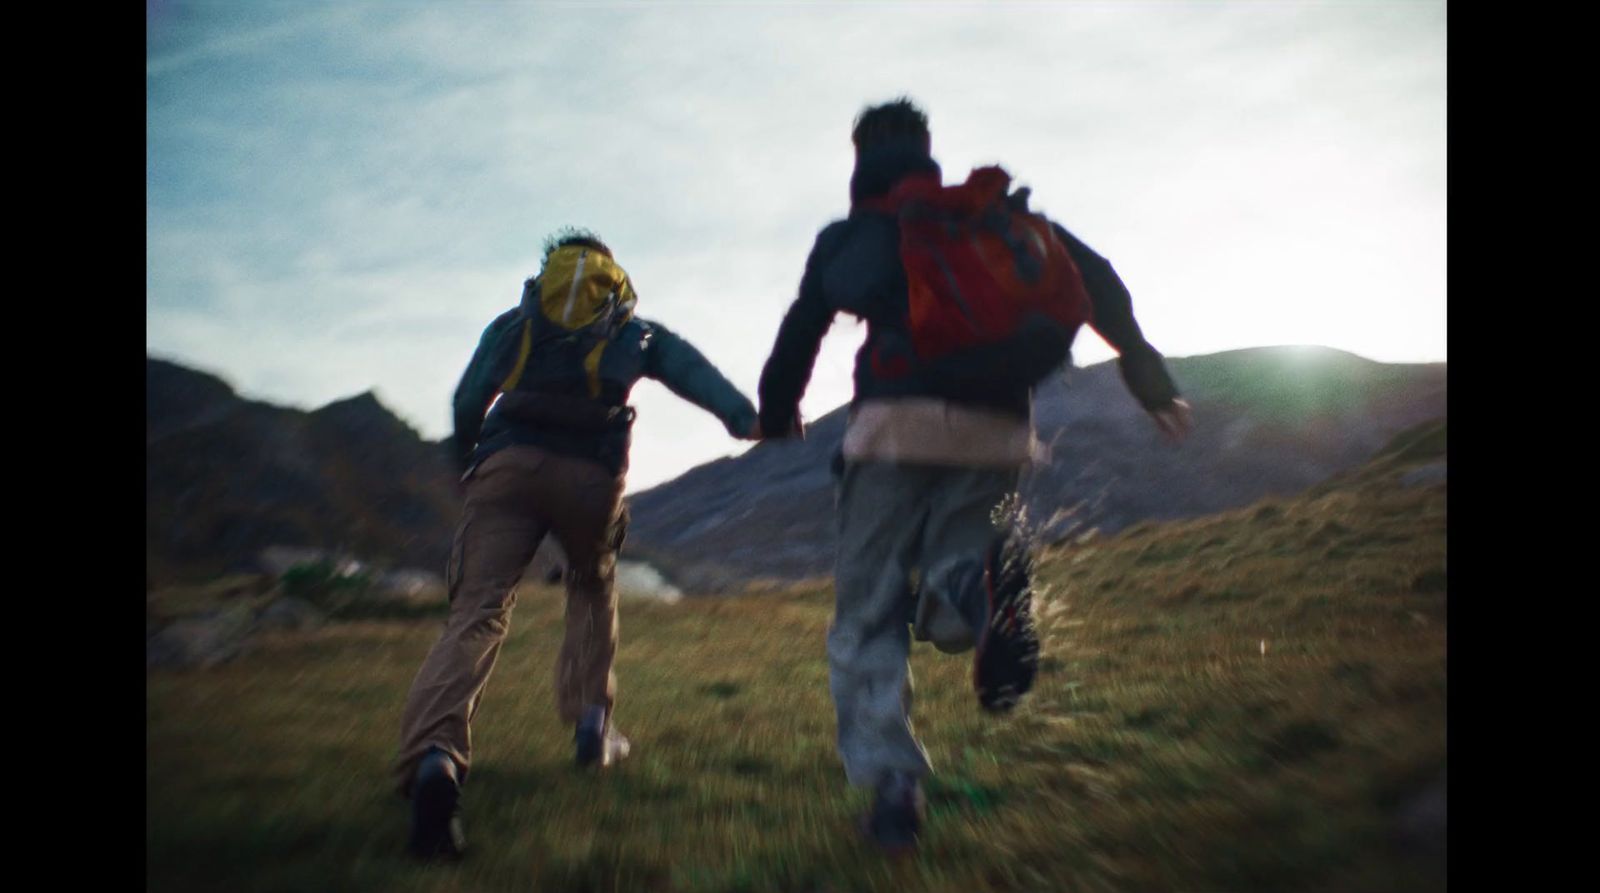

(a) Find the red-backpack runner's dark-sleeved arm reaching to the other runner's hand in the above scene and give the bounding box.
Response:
[758,222,845,437]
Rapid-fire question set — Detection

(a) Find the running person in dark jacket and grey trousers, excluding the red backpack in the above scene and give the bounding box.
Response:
[760,101,1190,850]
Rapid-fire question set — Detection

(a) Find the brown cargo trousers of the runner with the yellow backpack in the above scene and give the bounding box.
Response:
[395,447,627,794]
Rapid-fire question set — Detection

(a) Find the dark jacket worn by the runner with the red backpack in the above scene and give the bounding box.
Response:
[760,142,1178,434]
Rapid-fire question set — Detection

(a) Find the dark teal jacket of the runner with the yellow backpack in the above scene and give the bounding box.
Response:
[453,307,755,475]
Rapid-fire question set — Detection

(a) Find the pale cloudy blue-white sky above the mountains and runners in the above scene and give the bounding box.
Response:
[146,0,1446,490]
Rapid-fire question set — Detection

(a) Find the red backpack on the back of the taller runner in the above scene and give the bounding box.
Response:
[861,166,1093,376]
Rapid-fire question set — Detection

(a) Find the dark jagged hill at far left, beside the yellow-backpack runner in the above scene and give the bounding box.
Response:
[146,357,459,581]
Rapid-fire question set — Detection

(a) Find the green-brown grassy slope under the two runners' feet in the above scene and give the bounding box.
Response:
[146,427,1446,893]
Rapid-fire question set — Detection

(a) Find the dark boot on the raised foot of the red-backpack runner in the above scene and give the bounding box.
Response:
[973,536,1038,714]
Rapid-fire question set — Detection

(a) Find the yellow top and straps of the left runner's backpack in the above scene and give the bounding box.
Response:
[501,245,638,397]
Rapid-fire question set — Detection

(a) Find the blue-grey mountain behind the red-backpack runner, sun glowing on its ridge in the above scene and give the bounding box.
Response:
[629,347,1446,591]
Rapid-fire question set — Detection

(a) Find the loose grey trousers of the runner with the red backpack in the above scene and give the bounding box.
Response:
[827,463,1021,786]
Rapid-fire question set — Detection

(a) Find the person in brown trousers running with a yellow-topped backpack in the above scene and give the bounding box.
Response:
[395,232,758,858]
